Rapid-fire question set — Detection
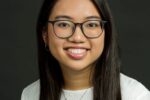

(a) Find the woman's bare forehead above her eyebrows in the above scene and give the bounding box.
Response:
[50,0,100,19]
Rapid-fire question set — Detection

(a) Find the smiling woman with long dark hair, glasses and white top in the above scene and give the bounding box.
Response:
[22,0,150,100]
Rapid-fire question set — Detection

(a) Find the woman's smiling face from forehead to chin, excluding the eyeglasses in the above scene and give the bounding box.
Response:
[43,0,105,71]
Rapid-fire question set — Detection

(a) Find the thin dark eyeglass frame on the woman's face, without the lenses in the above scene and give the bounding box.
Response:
[48,20,108,39]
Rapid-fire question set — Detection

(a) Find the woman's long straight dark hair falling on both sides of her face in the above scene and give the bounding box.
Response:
[37,0,121,100]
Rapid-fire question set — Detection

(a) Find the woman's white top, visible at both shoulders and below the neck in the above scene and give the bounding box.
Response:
[21,74,150,100]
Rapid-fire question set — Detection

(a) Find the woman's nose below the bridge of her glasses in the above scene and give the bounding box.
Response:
[68,25,86,43]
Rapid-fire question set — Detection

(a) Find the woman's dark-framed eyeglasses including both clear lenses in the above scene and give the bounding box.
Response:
[48,20,107,39]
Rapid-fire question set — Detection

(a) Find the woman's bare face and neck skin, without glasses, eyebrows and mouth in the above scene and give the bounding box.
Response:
[43,0,105,90]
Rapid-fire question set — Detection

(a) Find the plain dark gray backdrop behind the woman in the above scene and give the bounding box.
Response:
[0,0,150,100]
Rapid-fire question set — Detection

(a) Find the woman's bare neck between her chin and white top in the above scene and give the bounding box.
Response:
[62,67,92,90]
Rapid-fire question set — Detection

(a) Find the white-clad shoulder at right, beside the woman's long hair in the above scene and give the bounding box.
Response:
[120,73,150,100]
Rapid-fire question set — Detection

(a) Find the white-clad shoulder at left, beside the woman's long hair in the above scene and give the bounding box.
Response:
[21,80,40,100]
